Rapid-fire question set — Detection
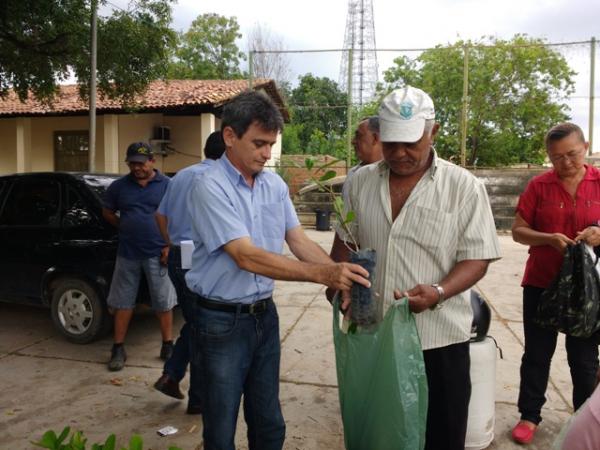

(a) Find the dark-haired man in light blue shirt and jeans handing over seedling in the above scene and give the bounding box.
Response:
[186,92,370,450]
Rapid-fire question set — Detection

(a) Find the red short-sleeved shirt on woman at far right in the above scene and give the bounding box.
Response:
[517,165,600,288]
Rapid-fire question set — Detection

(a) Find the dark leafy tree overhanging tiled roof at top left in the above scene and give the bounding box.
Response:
[0,0,175,102]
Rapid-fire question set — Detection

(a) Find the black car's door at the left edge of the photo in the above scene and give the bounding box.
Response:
[0,175,61,303]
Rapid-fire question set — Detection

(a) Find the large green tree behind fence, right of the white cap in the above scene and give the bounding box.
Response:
[383,35,575,166]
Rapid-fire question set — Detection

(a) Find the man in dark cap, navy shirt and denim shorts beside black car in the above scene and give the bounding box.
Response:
[102,142,176,371]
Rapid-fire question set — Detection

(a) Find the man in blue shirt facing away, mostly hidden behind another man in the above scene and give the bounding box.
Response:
[154,131,225,414]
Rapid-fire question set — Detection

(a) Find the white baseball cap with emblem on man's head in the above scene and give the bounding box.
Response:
[379,86,435,142]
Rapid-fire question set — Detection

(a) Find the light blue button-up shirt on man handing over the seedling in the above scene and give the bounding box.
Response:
[185,155,300,303]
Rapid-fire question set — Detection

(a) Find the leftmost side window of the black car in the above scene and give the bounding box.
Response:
[0,179,60,226]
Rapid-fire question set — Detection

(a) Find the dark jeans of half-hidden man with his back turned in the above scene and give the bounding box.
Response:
[163,246,201,406]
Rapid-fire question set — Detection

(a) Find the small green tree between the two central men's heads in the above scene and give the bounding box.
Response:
[290,73,347,150]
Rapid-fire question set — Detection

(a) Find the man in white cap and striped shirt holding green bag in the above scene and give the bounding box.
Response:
[333,86,500,450]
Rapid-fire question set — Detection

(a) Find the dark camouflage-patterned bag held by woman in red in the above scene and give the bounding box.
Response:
[534,242,600,338]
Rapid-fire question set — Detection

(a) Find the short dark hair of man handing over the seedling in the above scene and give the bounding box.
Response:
[221,91,283,138]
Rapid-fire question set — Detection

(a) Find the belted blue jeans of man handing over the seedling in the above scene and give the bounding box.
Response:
[192,300,285,450]
